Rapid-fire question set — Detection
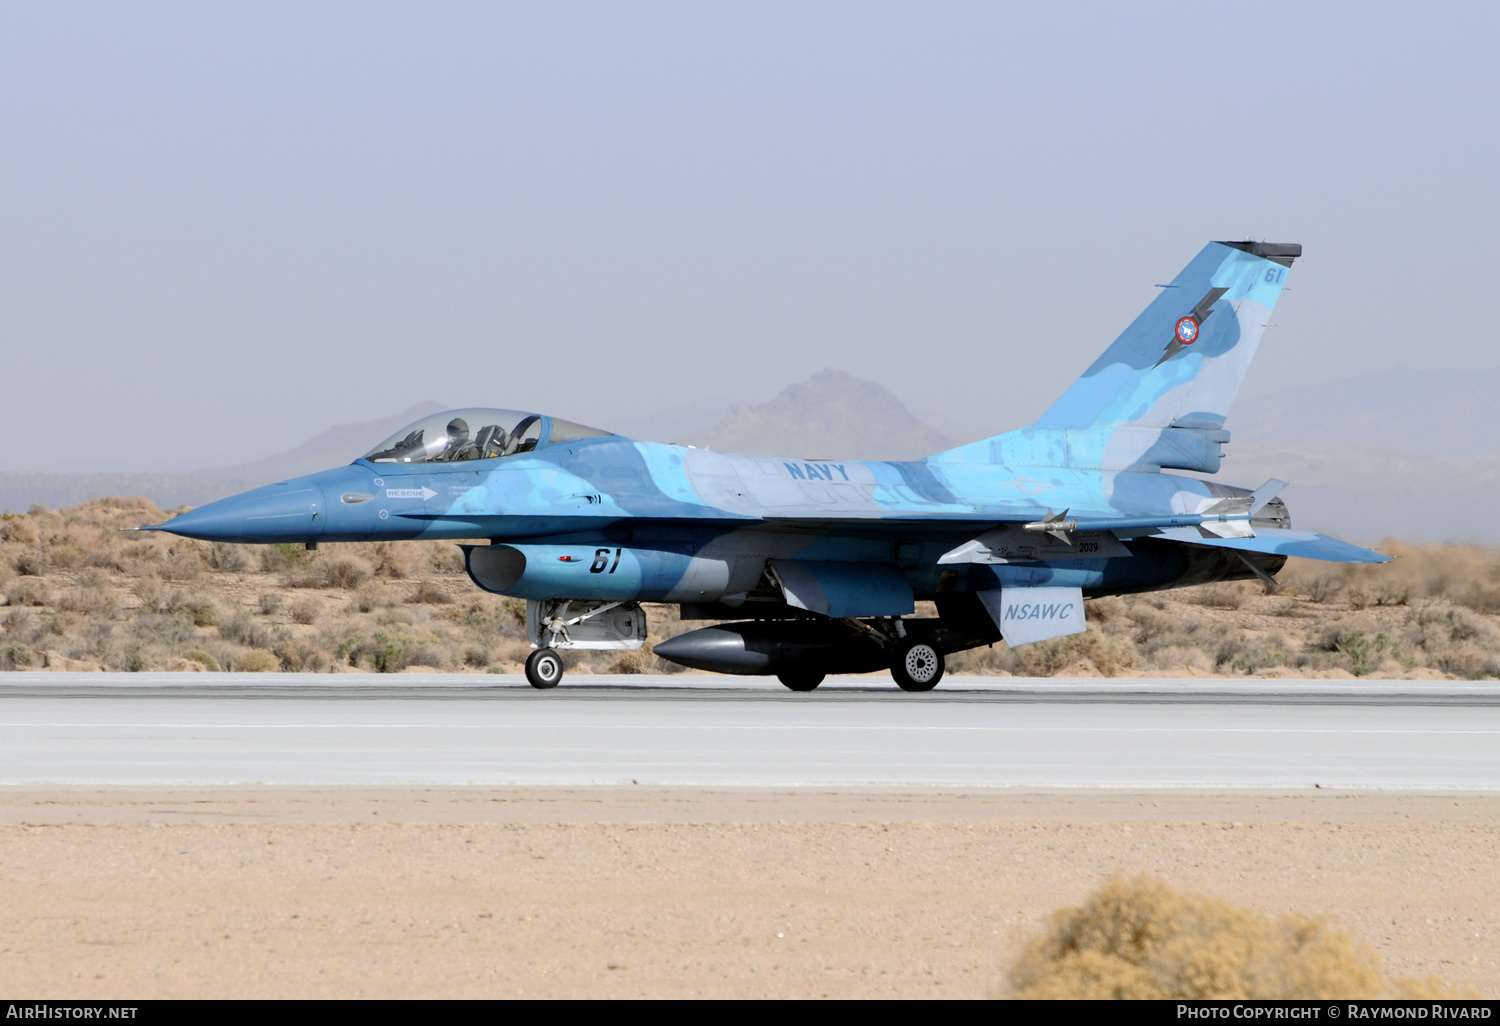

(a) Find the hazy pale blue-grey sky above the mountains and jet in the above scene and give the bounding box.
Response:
[0,0,1500,470]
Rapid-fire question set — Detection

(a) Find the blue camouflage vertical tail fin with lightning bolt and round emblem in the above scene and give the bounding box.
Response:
[935,242,1302,473]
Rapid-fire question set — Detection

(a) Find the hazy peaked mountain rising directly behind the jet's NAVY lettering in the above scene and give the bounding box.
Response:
[677,371,957,459]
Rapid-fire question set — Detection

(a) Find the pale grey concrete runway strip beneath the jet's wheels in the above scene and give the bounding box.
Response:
[0,674,1500,791]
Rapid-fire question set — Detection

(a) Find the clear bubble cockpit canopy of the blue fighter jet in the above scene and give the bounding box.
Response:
[363,408,611,464]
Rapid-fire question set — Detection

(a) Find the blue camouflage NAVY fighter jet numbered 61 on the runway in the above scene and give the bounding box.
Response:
[146,242,1389,692]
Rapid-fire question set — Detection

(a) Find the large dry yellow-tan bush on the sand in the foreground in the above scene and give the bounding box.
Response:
[1010,876,1442,1001]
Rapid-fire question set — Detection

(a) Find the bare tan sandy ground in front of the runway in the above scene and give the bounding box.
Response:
[0,788,1500,998]
